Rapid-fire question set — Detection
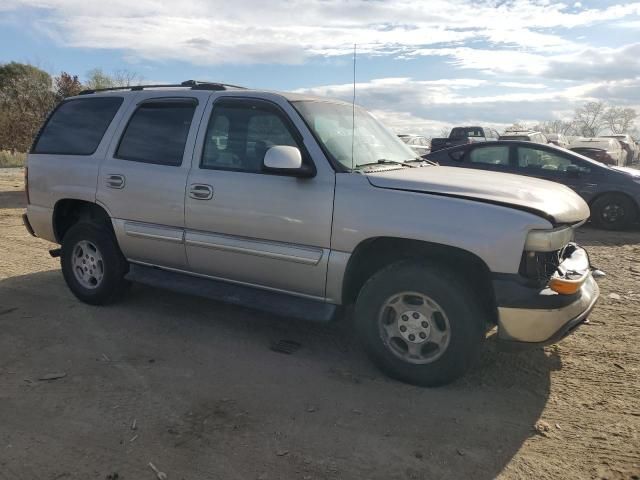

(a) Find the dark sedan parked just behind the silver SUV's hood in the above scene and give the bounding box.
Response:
[426,141,640,230]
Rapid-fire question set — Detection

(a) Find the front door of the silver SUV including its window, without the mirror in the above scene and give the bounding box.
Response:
[185,96,335,297]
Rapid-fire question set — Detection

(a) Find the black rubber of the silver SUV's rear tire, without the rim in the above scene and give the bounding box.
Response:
[60,222,129,305]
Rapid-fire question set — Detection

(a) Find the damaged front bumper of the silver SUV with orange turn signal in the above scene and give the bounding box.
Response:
[494,244,600,349]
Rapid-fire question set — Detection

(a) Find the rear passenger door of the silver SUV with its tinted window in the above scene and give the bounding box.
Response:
[97,91,210,269]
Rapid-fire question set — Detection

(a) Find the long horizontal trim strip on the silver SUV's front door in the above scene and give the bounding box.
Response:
[185,231,323,265]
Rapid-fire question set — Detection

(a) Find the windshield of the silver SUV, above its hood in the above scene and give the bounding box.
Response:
[292,100,416,169]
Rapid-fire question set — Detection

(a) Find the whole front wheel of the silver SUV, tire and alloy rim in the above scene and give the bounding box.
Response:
[354,260,487,387]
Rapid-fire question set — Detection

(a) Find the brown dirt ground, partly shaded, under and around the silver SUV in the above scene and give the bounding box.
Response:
[0,169,640,480]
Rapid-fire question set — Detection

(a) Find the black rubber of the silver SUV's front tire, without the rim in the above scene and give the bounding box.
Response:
[355,260,487,387]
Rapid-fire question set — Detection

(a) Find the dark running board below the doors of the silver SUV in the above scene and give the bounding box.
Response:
[126,264,337,322]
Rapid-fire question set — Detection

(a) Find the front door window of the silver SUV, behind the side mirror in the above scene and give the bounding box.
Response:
[200,100,300,173]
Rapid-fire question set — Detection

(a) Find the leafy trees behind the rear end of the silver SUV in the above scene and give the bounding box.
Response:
[0,62,142,152]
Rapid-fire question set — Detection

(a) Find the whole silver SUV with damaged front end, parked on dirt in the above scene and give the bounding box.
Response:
[24,81,599,385]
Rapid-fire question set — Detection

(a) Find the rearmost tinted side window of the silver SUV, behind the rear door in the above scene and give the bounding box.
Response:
[31,97,123,155]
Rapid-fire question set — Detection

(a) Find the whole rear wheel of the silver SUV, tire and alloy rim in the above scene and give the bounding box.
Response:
[60,222,129,305]
